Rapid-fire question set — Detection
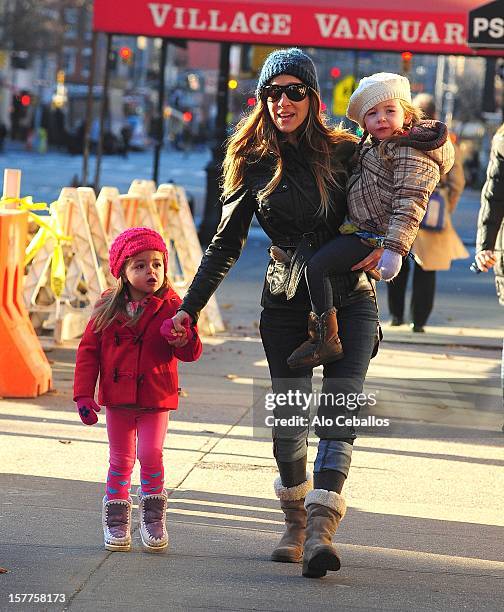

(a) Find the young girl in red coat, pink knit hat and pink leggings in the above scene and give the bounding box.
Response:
[74,227,201,552]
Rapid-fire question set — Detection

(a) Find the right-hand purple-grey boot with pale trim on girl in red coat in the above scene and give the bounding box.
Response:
[137,487,168,552]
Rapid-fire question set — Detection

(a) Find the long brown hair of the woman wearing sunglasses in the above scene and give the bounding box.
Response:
[222,88,357,212]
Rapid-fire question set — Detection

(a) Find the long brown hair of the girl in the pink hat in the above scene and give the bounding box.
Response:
[92,257,170,332]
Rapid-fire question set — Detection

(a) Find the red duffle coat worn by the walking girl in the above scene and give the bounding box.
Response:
[74,288,202,410]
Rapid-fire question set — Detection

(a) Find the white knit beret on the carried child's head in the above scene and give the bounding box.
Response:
[347,72,411,128]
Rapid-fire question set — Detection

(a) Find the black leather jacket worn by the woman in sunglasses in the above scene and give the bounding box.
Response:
[180,142,374,320]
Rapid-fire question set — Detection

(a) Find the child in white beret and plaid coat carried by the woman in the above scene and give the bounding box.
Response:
[288,72,453,368]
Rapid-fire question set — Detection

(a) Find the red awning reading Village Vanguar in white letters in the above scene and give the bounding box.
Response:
[94,0,504,55]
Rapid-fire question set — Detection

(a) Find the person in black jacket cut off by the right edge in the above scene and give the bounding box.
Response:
[476,124,504,416]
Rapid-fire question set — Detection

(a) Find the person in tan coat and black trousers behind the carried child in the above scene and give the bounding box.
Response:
[387,94,469,333]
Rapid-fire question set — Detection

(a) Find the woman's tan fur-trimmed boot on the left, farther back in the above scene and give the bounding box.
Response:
[271,474,313,563]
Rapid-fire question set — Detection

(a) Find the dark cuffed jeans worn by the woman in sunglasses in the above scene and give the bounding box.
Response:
[259,296,378,461]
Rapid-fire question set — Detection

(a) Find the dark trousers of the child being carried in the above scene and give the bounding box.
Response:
[305,235,373,315]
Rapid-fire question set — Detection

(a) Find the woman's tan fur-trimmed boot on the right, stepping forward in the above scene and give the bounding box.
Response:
[303,489,346,578]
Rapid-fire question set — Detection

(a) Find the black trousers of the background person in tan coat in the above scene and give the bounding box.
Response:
[387,257,436,327]
